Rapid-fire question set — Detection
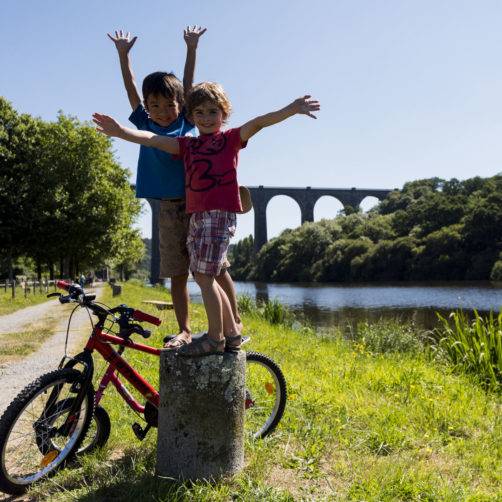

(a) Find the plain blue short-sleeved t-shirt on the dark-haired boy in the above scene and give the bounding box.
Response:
[129,103,197,199]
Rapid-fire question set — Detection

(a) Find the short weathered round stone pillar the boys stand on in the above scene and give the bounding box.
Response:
[157,351,246,480]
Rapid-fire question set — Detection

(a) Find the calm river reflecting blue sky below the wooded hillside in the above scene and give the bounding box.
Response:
[179,281,502,329]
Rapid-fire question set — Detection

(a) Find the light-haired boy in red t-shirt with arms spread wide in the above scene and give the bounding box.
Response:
[93,82,320,357]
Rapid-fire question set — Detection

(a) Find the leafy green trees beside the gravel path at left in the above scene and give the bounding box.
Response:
[0,97,144,279]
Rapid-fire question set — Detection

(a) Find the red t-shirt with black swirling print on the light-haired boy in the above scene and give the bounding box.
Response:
[174,128,247,213]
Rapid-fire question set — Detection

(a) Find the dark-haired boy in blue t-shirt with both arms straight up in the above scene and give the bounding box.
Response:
[108,26,242,347]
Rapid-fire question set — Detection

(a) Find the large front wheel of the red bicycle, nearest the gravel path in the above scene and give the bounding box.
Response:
[0,368,94,495]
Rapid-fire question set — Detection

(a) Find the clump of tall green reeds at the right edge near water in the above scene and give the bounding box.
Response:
[434,309,502,390]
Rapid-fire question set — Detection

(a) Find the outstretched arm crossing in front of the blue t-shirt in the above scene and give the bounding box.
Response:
[92,113,180,155]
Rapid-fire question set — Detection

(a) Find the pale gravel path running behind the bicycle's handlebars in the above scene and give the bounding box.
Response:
[0,288,103,415]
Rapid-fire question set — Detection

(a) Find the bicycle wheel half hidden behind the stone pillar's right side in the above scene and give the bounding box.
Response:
[246,352,287,439]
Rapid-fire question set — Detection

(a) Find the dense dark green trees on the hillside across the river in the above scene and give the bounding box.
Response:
[230,174,502,282]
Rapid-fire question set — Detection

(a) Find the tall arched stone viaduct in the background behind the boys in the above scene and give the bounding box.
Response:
[141,185,394,284]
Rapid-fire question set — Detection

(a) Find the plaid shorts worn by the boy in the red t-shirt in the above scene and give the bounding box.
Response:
[187,209,237,276]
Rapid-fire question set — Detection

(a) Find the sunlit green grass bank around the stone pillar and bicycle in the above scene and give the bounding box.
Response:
[13,284,502,502]
